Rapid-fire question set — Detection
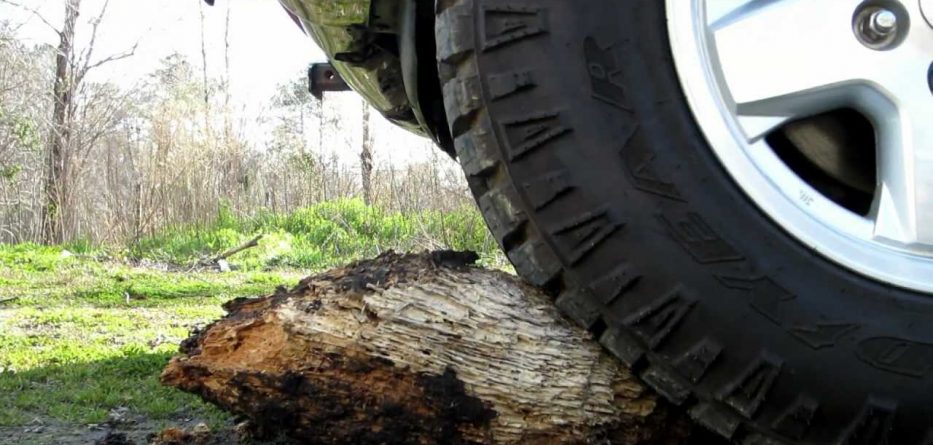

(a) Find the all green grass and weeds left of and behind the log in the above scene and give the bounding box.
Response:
[0,201,503,443]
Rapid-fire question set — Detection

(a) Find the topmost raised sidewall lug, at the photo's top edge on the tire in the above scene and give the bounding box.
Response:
[482,0,548,51]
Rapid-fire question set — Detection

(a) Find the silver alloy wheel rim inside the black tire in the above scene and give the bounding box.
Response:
[667,0,933,293]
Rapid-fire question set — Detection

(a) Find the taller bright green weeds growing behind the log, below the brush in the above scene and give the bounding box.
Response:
[130,199,504,270]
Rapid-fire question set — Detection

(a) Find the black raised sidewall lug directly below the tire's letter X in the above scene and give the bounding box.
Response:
[719,353,783,419]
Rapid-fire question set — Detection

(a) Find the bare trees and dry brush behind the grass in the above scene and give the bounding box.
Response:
[0,0,470,244]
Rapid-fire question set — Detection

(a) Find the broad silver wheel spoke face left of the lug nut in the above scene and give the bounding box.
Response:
[707,0,873,140]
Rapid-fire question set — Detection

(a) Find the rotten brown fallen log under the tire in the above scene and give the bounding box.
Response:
[161,252,690,445]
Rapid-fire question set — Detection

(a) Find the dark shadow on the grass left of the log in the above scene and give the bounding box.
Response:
[0,351,728,445]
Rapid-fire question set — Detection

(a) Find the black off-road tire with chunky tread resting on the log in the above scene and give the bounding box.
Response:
[436,0,933,445]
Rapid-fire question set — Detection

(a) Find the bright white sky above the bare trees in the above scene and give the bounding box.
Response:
[0,0,436,162]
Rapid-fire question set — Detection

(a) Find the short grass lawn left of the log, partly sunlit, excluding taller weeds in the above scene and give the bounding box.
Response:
[0,245,301,425]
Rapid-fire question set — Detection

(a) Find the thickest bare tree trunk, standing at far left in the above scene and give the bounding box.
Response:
[42,0,81,244]
